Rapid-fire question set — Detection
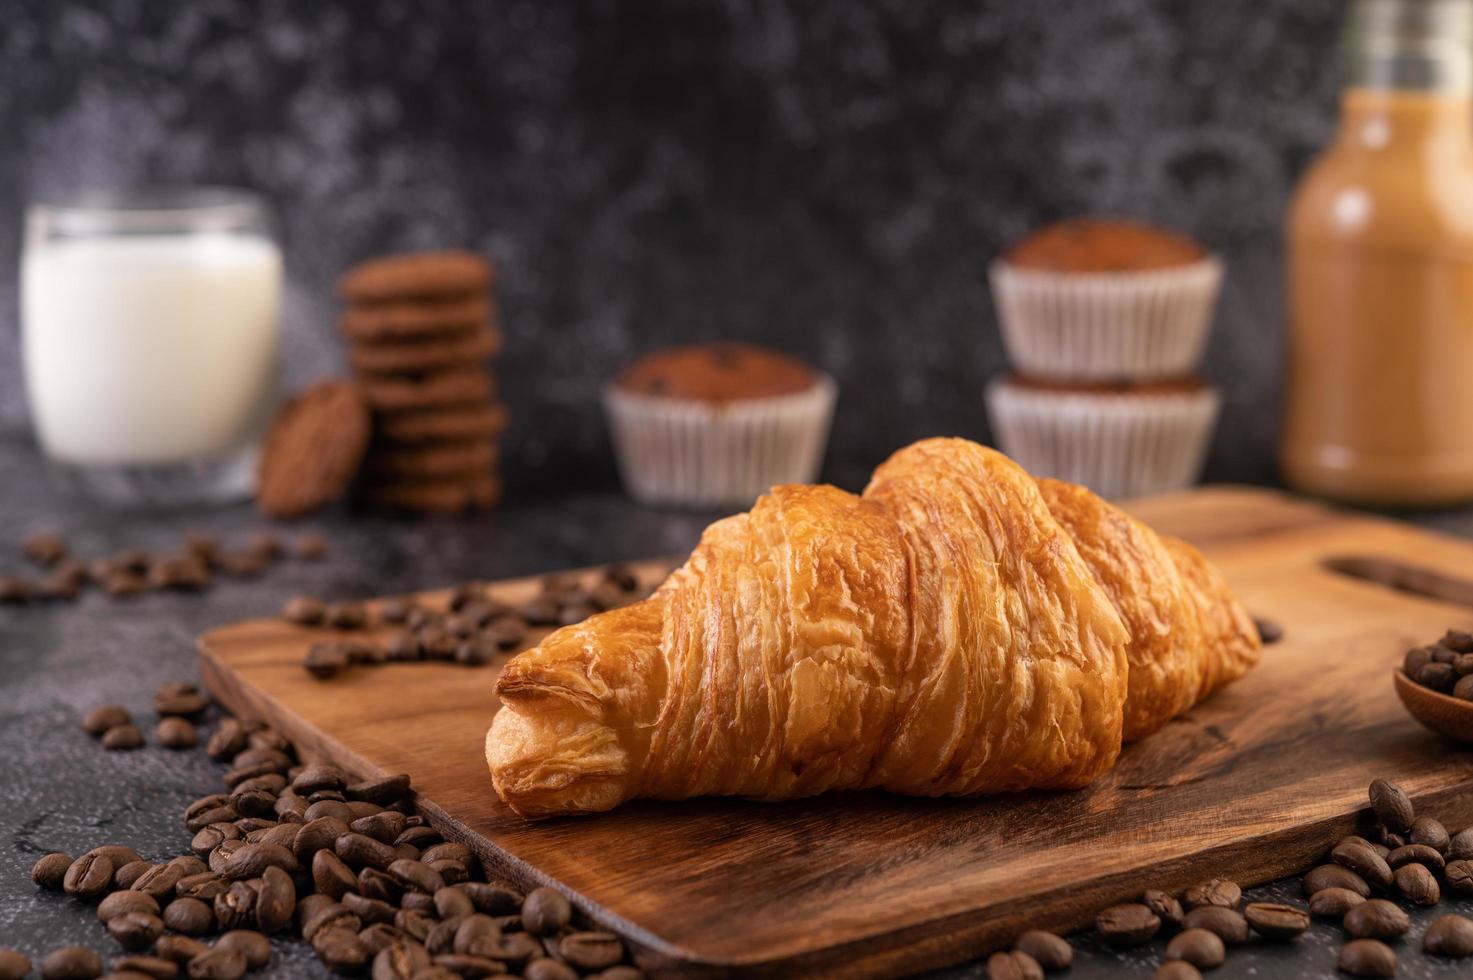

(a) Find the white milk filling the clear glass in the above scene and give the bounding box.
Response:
[21,233,281,466]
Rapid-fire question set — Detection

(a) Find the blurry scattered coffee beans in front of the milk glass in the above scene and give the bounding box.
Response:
[0,532,327,604]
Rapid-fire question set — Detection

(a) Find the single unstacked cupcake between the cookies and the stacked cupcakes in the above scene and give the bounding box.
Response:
[604,343,837,507]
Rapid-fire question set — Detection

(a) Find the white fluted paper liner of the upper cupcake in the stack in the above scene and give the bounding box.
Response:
[990,256,1223,380]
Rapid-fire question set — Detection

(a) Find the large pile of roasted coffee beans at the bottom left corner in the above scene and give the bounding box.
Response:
[0,684,642,980]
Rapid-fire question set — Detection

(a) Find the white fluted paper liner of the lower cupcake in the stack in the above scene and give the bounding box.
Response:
[987,379,1221,498]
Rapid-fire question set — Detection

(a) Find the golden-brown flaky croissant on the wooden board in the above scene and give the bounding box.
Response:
[486,439,1259,818]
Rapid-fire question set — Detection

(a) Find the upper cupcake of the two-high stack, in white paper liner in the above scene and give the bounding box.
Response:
[990,218,1223,380]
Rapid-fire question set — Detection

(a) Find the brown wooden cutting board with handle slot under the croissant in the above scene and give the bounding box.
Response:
[200,488,1473,977]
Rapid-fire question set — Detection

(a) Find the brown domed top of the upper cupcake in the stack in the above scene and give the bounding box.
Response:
[1003,218,1206,273]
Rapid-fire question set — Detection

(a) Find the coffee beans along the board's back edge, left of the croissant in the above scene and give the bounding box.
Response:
[281,564,648,679]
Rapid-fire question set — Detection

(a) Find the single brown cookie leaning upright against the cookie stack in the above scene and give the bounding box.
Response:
[256,380,371,517]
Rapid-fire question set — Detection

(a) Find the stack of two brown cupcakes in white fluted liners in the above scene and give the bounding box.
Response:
[987,220,1223,498]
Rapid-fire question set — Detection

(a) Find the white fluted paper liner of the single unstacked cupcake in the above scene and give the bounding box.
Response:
[604,376,838,507]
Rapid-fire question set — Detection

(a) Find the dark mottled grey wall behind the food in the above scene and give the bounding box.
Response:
[0,0,1342,491]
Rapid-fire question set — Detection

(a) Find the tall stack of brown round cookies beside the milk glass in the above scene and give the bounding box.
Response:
[340,252,507,511]
